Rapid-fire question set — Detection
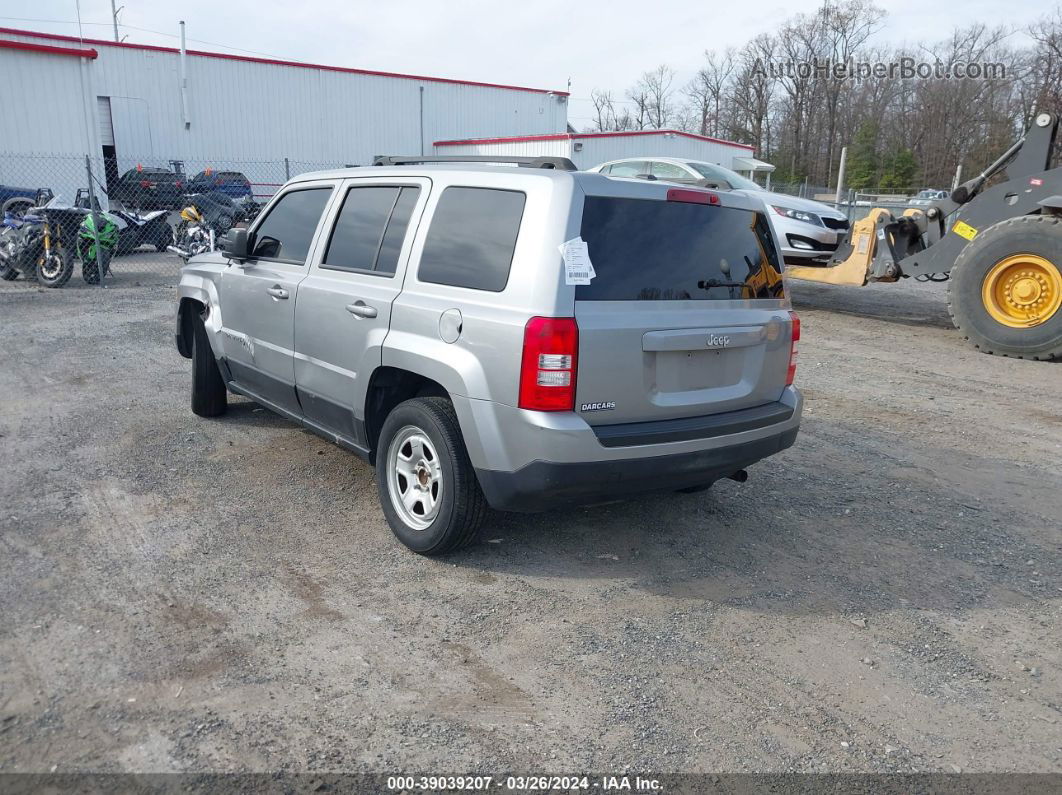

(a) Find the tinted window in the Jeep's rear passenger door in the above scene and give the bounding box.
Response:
[322,185,419,275]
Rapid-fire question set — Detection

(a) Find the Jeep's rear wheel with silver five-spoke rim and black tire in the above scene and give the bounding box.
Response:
[376,397,490,555]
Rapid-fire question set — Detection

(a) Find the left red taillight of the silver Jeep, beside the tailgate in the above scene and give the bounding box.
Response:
[517,317,579,411]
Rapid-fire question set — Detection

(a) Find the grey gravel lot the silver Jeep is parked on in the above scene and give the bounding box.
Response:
[0,258,1062,774]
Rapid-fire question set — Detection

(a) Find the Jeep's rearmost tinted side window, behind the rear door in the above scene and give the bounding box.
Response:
[417,188,527,293]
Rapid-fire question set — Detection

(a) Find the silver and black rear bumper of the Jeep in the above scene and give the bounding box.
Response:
[453,387,802,512]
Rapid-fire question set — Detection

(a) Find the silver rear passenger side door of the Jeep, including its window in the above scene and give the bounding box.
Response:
[294,177,430,447]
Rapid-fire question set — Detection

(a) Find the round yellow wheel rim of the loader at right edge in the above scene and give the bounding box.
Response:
[981,254,1062,328]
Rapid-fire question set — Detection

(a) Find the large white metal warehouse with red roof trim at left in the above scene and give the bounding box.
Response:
[0,28,568,198]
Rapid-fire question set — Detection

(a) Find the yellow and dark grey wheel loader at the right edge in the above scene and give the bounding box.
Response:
[786,113,1062,359]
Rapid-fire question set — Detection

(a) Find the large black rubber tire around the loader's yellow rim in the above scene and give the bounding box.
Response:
[947,215,1062,360]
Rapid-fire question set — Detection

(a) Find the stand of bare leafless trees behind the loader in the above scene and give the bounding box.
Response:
[594,0,1062,189]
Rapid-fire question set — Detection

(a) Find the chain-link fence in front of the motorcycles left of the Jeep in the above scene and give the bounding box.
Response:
[0,152,339,290]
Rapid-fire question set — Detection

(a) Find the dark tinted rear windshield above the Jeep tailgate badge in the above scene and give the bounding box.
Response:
[576,196,783,300]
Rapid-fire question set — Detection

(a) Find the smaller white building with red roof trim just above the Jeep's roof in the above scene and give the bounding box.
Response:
[434,129,774,174]
